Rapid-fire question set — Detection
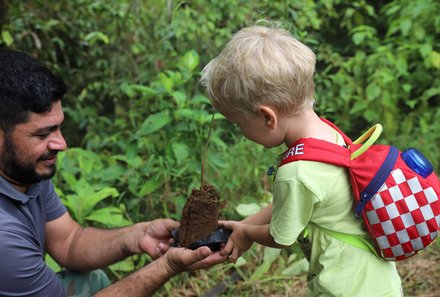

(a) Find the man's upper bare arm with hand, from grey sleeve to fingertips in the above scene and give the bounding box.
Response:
[46,213,175,270]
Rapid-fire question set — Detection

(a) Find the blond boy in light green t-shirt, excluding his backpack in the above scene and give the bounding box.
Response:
[201,26,401,297]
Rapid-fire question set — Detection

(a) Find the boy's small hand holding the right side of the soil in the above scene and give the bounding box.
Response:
[219,221,254,263]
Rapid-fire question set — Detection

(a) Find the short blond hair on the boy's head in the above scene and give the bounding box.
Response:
[201,26,315,114]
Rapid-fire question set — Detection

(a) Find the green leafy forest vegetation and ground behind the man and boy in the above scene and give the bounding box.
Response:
[0,0,440,296]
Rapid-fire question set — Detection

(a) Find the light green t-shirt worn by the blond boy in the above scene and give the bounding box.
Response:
[270,134,401,297]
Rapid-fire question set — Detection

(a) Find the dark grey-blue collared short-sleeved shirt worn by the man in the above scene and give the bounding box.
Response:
[0,177,66,297]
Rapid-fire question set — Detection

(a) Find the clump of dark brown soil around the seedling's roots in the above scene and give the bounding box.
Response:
[179,185,220,247]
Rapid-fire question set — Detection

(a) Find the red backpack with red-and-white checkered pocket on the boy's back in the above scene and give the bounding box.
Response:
[279,119,440,261]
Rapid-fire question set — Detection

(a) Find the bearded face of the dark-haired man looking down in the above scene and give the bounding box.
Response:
[0,101,67,186]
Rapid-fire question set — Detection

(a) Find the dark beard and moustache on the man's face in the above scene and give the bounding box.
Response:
[0,136,57,185]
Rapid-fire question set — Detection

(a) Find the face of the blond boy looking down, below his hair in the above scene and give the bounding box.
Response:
[216,107,284,148]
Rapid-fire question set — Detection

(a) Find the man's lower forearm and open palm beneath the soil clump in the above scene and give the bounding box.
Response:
[94,247,228,297]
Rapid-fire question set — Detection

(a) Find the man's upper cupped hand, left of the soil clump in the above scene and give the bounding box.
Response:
[139,219,179,259]
